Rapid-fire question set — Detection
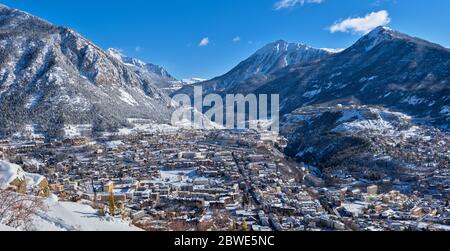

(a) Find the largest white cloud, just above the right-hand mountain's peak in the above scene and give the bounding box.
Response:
[330,10,391,34]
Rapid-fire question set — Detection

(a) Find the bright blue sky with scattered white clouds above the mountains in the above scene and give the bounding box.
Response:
[1,0,450,78]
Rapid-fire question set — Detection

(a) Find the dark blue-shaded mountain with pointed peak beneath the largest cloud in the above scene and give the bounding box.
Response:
[255,27,450,129]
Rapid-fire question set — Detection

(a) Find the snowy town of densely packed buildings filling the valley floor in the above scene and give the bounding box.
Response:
[0,123,450,231]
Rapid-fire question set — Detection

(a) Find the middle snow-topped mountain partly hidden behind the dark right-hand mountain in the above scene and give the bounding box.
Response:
[177,40,334,94]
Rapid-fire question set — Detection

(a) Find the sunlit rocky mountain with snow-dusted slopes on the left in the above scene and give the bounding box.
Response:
[0,5,171,136]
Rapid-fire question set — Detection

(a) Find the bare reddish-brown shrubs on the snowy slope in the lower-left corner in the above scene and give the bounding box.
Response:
[0,190,46,230]
